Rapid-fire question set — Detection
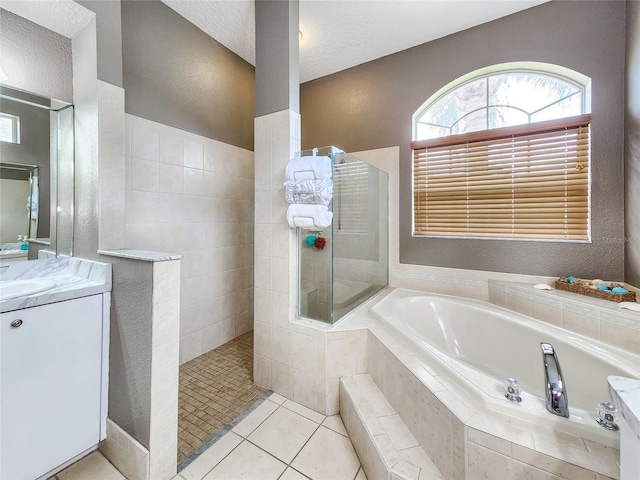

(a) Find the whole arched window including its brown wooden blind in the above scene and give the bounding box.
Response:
[411,67,591,241]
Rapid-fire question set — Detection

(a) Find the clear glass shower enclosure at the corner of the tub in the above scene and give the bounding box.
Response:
[298,147,389,323]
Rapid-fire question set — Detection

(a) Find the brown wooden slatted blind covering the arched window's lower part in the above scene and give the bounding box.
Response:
[411,115,591,240]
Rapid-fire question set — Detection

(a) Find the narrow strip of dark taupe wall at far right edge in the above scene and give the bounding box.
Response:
[624,1,640,287]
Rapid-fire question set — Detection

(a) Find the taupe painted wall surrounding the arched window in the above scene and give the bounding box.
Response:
[301,1,625,280]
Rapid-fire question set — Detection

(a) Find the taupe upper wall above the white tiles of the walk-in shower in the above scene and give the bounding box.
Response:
[122,0,255,150]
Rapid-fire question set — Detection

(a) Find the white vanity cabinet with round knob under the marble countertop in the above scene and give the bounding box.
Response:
[0,293,110,480]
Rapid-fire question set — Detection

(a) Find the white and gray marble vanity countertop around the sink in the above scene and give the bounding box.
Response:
[0,257,111,312]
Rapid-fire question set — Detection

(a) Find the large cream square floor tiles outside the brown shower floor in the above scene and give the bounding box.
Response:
[53,393,367,480]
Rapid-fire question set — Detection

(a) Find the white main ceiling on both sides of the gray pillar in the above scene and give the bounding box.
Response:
[162,0,549,82]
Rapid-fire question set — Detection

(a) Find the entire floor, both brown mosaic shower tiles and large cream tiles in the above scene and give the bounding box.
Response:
[53,332,366,480]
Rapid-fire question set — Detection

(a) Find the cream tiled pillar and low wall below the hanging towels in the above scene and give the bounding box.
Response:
[253,110,366,415]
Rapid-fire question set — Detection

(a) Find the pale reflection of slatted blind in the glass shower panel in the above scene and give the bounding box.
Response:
[333,160,369,234]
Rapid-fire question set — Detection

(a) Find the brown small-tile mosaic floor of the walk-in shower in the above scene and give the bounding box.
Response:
[178,331,265,464]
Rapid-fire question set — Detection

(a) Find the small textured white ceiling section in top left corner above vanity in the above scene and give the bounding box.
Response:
[0,0,95,38]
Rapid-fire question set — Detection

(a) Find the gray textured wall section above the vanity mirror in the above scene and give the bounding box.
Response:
[0,8,73,103]
